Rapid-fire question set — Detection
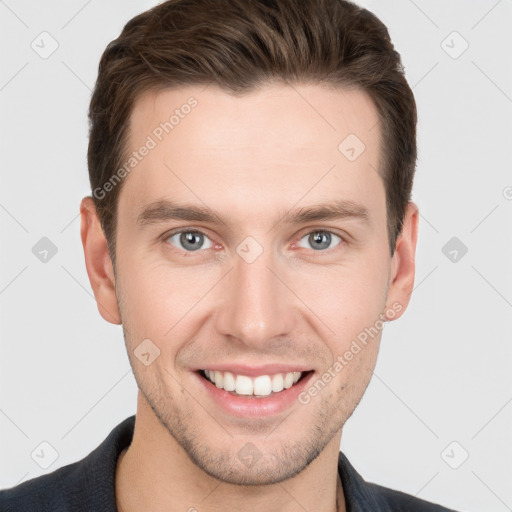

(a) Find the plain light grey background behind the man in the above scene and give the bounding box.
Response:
[0,0,512,512]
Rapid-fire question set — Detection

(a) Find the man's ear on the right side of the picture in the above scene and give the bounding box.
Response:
[386,201,419,320]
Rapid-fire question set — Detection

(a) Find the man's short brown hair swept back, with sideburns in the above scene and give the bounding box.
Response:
[87,0,417,265]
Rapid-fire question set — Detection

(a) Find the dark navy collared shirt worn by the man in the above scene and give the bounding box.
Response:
[0,416,453,512]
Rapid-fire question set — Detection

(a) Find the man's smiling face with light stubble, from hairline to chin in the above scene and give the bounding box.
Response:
[89,85,416,484]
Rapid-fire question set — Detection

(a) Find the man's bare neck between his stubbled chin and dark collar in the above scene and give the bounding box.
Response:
[115,400,345,512]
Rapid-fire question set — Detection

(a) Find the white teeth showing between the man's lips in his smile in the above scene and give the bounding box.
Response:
[198,370,313,398]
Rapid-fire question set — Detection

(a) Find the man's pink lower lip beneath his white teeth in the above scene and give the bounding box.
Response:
[195,371,314,418]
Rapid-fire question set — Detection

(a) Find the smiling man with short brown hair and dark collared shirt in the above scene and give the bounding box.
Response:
[0,0,456,512]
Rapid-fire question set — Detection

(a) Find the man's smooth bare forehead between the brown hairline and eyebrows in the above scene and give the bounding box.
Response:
[120,84,384,226]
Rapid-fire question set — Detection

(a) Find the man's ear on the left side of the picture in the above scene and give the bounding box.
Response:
[80,196,122,324]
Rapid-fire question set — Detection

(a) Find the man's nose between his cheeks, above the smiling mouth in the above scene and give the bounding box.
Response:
[215,240,297,350]
